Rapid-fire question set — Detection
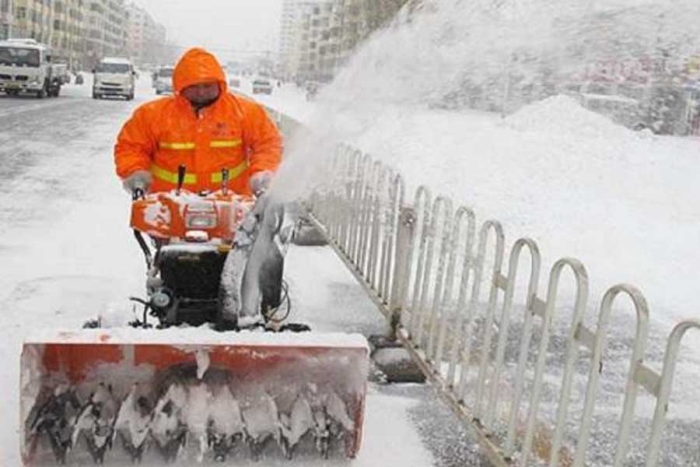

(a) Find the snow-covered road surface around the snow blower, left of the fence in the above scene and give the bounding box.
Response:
[0,82,487,467]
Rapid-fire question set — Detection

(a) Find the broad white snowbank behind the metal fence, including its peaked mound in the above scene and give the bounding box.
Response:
[274,88,700,336]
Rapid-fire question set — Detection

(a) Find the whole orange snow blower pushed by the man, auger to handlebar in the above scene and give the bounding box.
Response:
[20,168,369,466]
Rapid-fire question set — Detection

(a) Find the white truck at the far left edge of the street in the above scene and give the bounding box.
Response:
[0,39,63,99]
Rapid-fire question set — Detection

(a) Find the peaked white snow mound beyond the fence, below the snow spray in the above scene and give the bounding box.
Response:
[505,95,632,138]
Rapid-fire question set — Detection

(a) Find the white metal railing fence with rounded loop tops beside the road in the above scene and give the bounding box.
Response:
[268,108,700,467]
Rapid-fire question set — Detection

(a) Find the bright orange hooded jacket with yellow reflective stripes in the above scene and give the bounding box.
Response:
[114,48,282,195]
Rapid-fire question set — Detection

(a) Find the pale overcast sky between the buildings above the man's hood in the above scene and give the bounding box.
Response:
[135,0,282,58]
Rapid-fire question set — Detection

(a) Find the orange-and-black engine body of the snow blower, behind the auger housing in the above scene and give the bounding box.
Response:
[131,168,292,330]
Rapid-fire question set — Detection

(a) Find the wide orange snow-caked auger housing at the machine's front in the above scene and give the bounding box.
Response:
[20,330,368,466]
